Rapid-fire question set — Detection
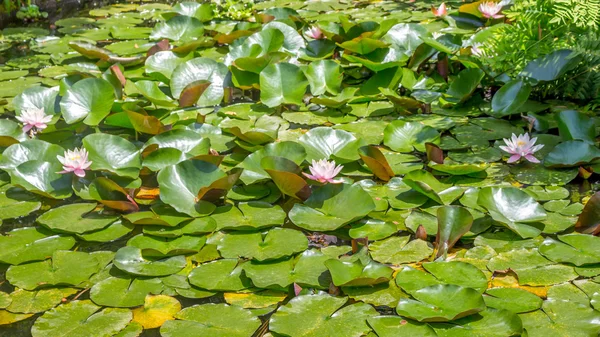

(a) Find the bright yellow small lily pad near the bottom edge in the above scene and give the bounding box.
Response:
[133,295,181,329]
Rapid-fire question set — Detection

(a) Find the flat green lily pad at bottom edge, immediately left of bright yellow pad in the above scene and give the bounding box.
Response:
[31,301,132,337]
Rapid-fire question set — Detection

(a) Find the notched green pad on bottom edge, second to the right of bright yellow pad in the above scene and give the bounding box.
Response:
[269,295,377,337]
